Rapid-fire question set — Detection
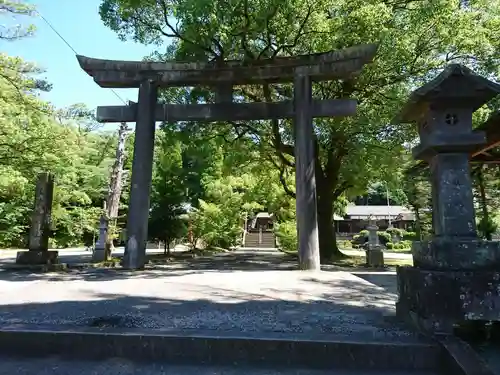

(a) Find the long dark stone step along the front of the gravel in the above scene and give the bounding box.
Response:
[0,325,443,374]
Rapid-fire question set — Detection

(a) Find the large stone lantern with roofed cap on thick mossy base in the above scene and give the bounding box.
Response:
[396,64,500,333]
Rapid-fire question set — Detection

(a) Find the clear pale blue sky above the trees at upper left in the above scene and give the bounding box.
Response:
[2,0,164,108]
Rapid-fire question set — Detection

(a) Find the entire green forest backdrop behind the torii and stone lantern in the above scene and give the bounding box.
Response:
[0,0,500,258]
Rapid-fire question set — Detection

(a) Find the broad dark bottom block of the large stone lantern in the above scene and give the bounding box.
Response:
[396,266,500,334]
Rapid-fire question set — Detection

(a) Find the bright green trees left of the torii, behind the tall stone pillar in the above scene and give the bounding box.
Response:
[0,1,120,251]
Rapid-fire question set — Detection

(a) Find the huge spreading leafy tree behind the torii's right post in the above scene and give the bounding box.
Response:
[100,0,500,259]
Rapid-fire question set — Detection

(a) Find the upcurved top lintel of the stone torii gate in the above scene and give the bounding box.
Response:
[77,44,377,88]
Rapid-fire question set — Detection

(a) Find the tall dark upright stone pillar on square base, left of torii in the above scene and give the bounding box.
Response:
[16,173,58,264]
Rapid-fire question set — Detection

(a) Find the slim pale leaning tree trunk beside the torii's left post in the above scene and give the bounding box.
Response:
[106,122,129,252]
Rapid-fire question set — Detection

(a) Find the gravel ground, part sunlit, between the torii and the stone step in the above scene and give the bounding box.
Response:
[0,254,410,338]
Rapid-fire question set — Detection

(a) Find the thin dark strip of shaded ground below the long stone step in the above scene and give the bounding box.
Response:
[0,358,433,375]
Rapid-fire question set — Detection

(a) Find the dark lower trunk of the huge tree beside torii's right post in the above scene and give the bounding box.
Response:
[317,189,345,262]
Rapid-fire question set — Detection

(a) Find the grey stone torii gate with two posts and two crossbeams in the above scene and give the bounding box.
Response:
[77,45,377,269]
